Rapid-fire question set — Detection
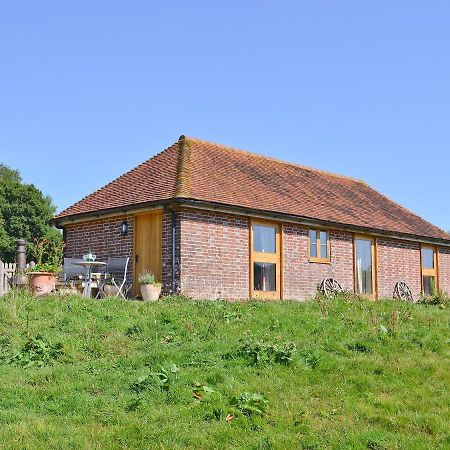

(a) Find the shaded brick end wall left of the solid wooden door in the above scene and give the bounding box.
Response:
[64,216,133,280]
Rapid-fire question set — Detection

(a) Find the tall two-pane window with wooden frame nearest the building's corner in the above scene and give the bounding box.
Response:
[250,221,281,299]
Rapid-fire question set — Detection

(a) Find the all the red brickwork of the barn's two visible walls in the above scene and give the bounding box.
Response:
[65,210,450,300]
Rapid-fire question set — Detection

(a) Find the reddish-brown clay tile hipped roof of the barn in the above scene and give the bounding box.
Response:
[55,136,450,241]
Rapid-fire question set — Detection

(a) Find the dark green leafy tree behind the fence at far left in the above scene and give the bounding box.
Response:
[0,164,61,261]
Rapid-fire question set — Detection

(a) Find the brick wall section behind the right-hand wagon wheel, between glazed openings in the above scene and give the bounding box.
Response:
[377,239,422,300]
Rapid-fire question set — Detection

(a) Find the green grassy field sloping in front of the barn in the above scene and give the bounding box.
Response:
[0,294,450,449]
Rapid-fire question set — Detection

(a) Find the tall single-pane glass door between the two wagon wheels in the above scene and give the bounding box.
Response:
[354,236,376,299]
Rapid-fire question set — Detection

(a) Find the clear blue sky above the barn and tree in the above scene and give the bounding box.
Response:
[0,0,450,230]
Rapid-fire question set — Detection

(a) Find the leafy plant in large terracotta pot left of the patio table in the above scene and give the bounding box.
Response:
[28,238,63,297]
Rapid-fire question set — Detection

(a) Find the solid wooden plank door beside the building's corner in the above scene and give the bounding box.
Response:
[133,211,162,295]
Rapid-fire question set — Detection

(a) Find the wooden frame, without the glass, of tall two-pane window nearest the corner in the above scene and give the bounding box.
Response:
[249,219,283,300]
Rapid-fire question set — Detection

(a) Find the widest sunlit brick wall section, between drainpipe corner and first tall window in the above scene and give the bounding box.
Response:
[178,211,249,299]
